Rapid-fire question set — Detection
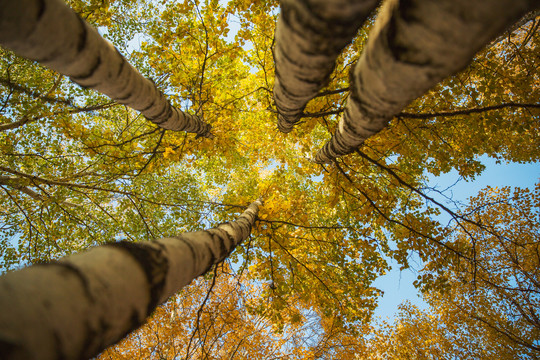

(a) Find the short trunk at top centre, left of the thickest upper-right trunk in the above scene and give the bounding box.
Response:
[274,0,379,132]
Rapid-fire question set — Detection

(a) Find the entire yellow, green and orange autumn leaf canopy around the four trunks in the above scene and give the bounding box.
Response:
[0,0,540,359]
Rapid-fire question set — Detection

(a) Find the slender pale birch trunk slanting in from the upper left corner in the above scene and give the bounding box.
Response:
[0,0,212,137]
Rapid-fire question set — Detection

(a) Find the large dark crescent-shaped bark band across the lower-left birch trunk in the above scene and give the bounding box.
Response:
[105,241,169,316]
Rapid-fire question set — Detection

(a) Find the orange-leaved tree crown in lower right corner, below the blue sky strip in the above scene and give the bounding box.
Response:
[369,184,540,359]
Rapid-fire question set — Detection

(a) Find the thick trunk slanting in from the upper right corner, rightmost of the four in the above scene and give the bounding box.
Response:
[315,0,540,163]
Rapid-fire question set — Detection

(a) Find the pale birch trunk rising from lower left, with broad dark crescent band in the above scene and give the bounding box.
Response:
[0,200,261,360]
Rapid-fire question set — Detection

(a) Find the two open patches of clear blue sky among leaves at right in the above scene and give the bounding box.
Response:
[374,157,540,320]
